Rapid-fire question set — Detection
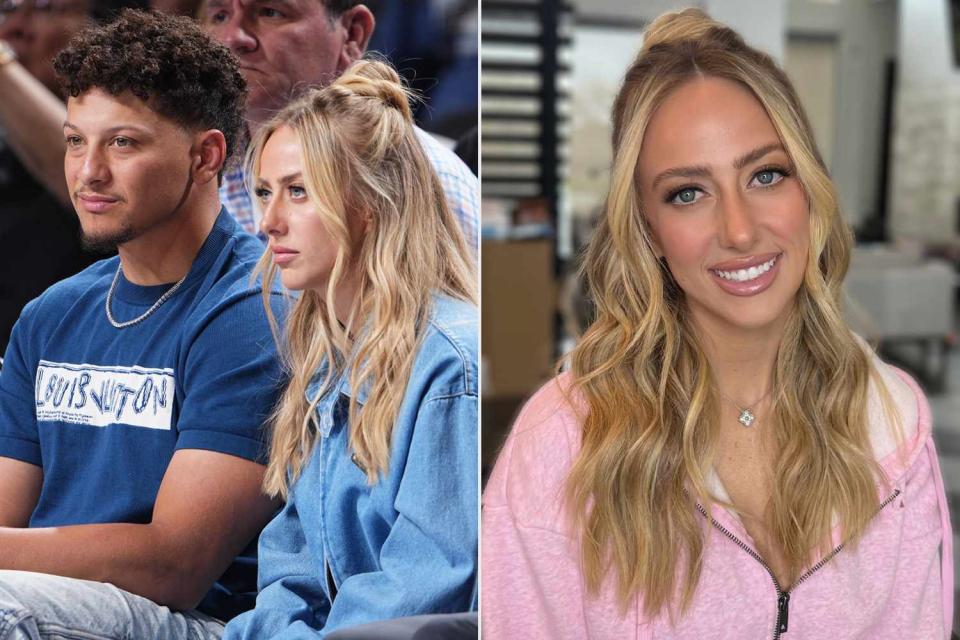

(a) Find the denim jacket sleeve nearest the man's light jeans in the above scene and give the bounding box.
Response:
[223,498,329,640]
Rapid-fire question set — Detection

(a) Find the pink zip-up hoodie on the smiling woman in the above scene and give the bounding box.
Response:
[481,358,953,640]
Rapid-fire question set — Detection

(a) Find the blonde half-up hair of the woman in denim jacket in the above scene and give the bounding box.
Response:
[247,60,476,497]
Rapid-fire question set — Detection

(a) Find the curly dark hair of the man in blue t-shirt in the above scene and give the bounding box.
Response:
[53,9,247,166]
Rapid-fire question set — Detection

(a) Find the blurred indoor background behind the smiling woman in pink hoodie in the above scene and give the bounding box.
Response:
[481,0,960,624]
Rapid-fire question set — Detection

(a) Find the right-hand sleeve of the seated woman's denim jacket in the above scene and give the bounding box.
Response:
[319,394,477,637]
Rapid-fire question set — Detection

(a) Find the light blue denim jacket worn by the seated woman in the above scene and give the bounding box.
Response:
[224,296,478,640]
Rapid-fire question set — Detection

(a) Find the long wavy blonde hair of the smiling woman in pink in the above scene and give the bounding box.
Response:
[567,9,889,615]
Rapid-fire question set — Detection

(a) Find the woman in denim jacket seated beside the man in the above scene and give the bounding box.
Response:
[225,61,478,639]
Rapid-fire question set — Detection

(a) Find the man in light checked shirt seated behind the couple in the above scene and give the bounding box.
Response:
[200,0,480,252]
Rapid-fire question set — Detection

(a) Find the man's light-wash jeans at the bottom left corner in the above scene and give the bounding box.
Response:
[0,571,223,640]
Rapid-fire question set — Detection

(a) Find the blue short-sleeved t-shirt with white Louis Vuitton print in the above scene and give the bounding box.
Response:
[0,210,282,619]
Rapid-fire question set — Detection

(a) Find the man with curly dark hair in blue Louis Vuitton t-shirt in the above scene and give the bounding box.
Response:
[0,11,281,639]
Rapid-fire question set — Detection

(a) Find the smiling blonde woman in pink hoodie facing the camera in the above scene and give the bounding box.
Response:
[482,10,953,640]
